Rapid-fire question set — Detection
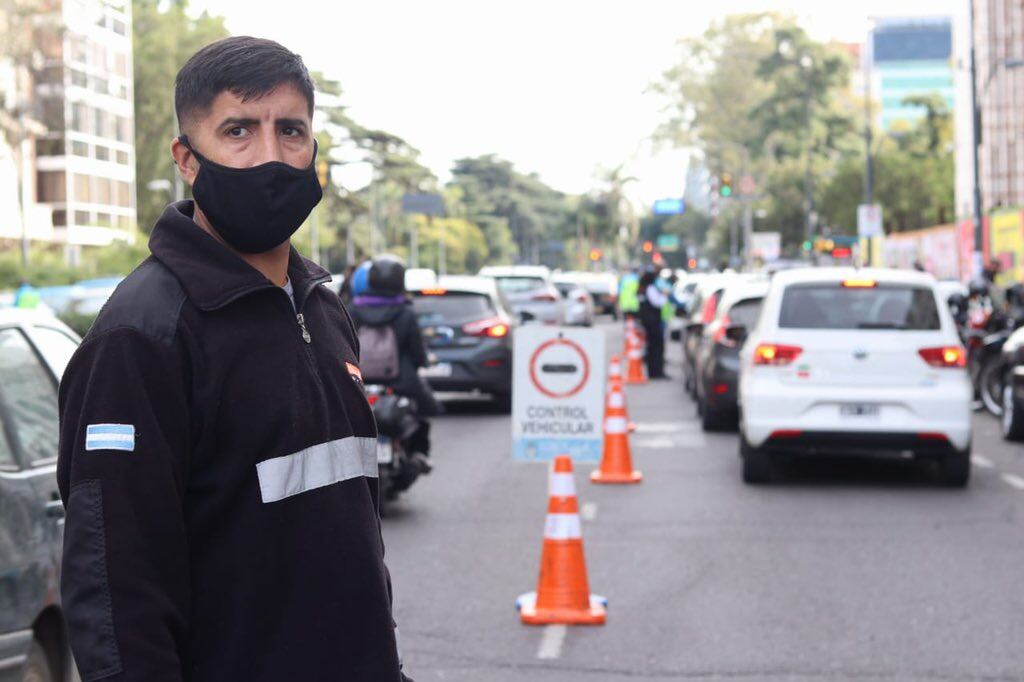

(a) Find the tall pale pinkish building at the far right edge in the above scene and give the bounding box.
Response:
[974,0,1024,213]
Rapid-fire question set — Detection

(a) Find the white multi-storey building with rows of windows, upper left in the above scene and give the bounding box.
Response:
[35,0,135,261]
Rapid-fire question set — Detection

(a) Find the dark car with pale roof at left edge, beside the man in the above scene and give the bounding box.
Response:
[0,309,80,682]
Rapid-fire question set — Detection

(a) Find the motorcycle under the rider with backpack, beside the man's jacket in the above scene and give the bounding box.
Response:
[367,385,432,504]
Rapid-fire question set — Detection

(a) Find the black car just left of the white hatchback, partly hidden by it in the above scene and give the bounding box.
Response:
[694,280,768,431]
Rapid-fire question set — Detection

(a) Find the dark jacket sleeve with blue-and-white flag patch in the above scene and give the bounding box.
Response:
[57,328,191,682]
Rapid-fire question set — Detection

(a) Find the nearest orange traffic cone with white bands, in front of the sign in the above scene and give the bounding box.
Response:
[515,455,608,625]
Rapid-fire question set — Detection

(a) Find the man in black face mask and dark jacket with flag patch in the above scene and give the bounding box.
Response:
[58,38,408,682]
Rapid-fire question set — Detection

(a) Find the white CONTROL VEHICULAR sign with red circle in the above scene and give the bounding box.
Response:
[512,326,605,462]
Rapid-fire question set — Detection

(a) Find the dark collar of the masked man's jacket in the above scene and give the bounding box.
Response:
[150,200,331,310]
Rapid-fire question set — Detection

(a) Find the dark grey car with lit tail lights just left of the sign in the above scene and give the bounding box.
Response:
[411,275,516,409]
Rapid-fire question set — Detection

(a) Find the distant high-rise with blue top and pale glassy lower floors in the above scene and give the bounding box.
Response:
[870,16,953,133]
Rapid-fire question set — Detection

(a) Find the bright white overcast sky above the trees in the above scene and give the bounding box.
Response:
[191,0,967,203]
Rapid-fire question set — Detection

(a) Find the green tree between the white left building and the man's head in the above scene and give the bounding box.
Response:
[132,0,228,232]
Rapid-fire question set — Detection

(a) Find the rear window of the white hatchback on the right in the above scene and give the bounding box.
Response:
[778,283,941,331]
